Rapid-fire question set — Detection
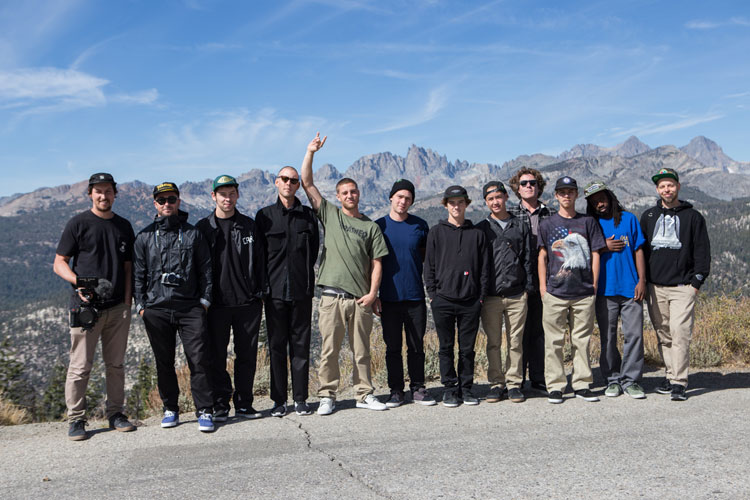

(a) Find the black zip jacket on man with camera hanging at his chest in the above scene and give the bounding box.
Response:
[133,210,211,311]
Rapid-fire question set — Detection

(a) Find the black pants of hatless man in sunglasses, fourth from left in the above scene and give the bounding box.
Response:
[266,298,312,404]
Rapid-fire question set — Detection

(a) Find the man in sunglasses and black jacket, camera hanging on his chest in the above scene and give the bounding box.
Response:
[133,182,214,432]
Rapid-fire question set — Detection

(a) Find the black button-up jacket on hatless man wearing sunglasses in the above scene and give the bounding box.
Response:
[255,197,320,300]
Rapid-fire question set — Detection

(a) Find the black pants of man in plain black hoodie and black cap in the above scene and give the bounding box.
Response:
[432,296,482,392]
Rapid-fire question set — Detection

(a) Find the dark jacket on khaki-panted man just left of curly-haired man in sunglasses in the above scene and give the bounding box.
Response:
[477,215,534,297]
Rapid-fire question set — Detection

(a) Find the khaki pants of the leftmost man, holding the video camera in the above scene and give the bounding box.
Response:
[65,303,130,421]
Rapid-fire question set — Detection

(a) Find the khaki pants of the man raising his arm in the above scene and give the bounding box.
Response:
[318,295,375,401]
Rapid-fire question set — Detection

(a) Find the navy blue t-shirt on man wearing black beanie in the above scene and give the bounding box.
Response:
[375,215,429,302]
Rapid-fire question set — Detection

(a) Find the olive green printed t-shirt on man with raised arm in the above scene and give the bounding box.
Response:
[317,198,388,297]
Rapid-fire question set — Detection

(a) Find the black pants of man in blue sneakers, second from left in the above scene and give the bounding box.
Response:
[143,306,213,412]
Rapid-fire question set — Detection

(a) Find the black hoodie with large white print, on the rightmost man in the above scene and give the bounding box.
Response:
[641,200,711,288]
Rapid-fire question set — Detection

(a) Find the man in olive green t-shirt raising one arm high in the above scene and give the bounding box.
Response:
[301,133,388,415]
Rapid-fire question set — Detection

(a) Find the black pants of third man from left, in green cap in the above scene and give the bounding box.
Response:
[208,300,261,410]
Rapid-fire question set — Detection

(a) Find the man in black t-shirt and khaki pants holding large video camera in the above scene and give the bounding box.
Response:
[53,173,135,441]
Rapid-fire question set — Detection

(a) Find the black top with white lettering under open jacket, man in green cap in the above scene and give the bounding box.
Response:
[213,214,253,306]
